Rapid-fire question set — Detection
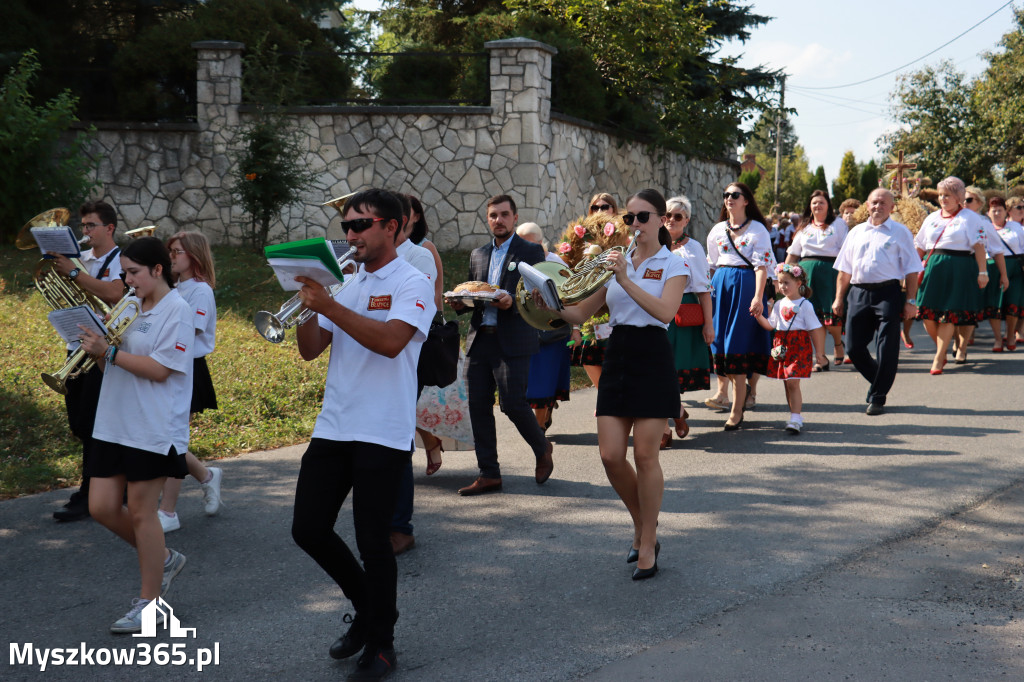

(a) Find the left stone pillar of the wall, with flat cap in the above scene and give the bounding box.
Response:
[191,40,246,240]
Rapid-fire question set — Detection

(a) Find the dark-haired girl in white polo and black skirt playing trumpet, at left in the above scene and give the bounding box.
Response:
[81,237,196,633]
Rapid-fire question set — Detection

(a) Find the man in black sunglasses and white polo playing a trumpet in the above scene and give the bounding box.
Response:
[292,189,435,680]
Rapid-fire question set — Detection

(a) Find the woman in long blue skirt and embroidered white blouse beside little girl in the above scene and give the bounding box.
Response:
[708,182,775,431]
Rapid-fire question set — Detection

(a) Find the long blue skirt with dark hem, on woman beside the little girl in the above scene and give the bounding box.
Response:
[711,267,771,377]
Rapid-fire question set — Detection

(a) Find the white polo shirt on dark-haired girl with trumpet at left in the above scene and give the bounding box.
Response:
[92,289,196,455]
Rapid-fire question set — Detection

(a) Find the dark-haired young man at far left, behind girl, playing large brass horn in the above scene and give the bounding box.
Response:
[47,202,125,521]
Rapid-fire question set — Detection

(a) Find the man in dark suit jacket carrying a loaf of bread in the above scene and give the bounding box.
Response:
[450,195,554,496]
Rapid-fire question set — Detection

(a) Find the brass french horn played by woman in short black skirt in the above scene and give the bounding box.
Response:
[515,231,639,331]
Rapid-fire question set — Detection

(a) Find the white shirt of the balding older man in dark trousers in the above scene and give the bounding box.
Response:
[833,218,925,284]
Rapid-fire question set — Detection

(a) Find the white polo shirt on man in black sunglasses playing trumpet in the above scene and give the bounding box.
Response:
[313,253,436,452]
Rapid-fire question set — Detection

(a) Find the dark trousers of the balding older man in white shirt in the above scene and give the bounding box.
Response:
[846,284,905,404]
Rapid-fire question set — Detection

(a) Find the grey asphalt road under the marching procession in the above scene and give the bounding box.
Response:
[0,327,1024,682]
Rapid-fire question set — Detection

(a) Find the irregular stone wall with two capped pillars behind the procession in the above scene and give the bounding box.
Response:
[79,38,738,251]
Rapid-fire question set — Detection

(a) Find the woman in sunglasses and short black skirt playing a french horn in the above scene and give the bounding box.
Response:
[534,189,689,580]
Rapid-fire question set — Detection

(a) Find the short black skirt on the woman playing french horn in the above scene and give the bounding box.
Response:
[597,325,680,419]
